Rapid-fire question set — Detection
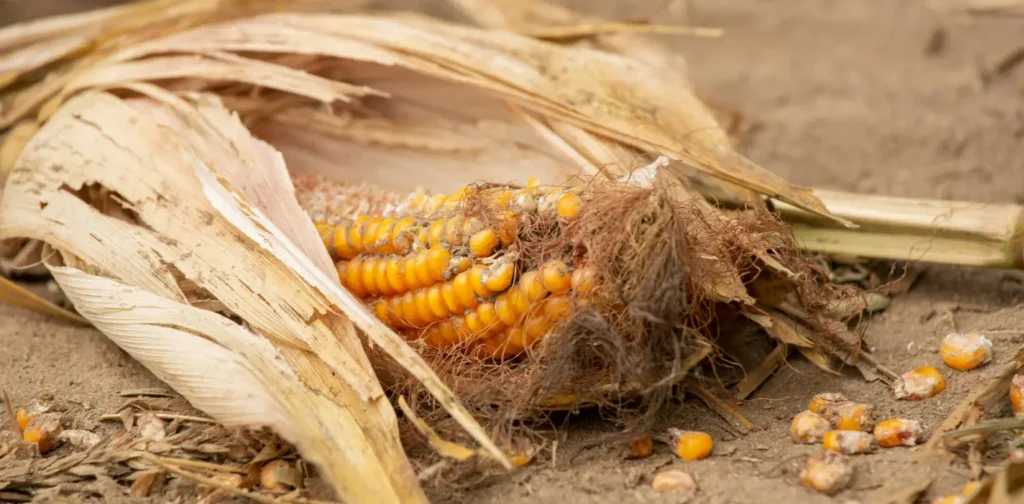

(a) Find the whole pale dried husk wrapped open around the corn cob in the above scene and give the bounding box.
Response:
[0,0,860,502]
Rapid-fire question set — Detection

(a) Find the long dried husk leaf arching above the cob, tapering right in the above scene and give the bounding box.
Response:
[2,7,827,220]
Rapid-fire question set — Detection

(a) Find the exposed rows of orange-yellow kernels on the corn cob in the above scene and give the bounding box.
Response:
[315,180,594,359]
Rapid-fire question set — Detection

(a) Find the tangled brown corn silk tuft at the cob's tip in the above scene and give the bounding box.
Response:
[295,175,857,445]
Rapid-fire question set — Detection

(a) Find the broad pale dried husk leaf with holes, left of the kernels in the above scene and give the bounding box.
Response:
[0,88,503,502]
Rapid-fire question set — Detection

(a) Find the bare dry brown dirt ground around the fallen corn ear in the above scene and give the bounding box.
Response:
[0,0,1024,504]
